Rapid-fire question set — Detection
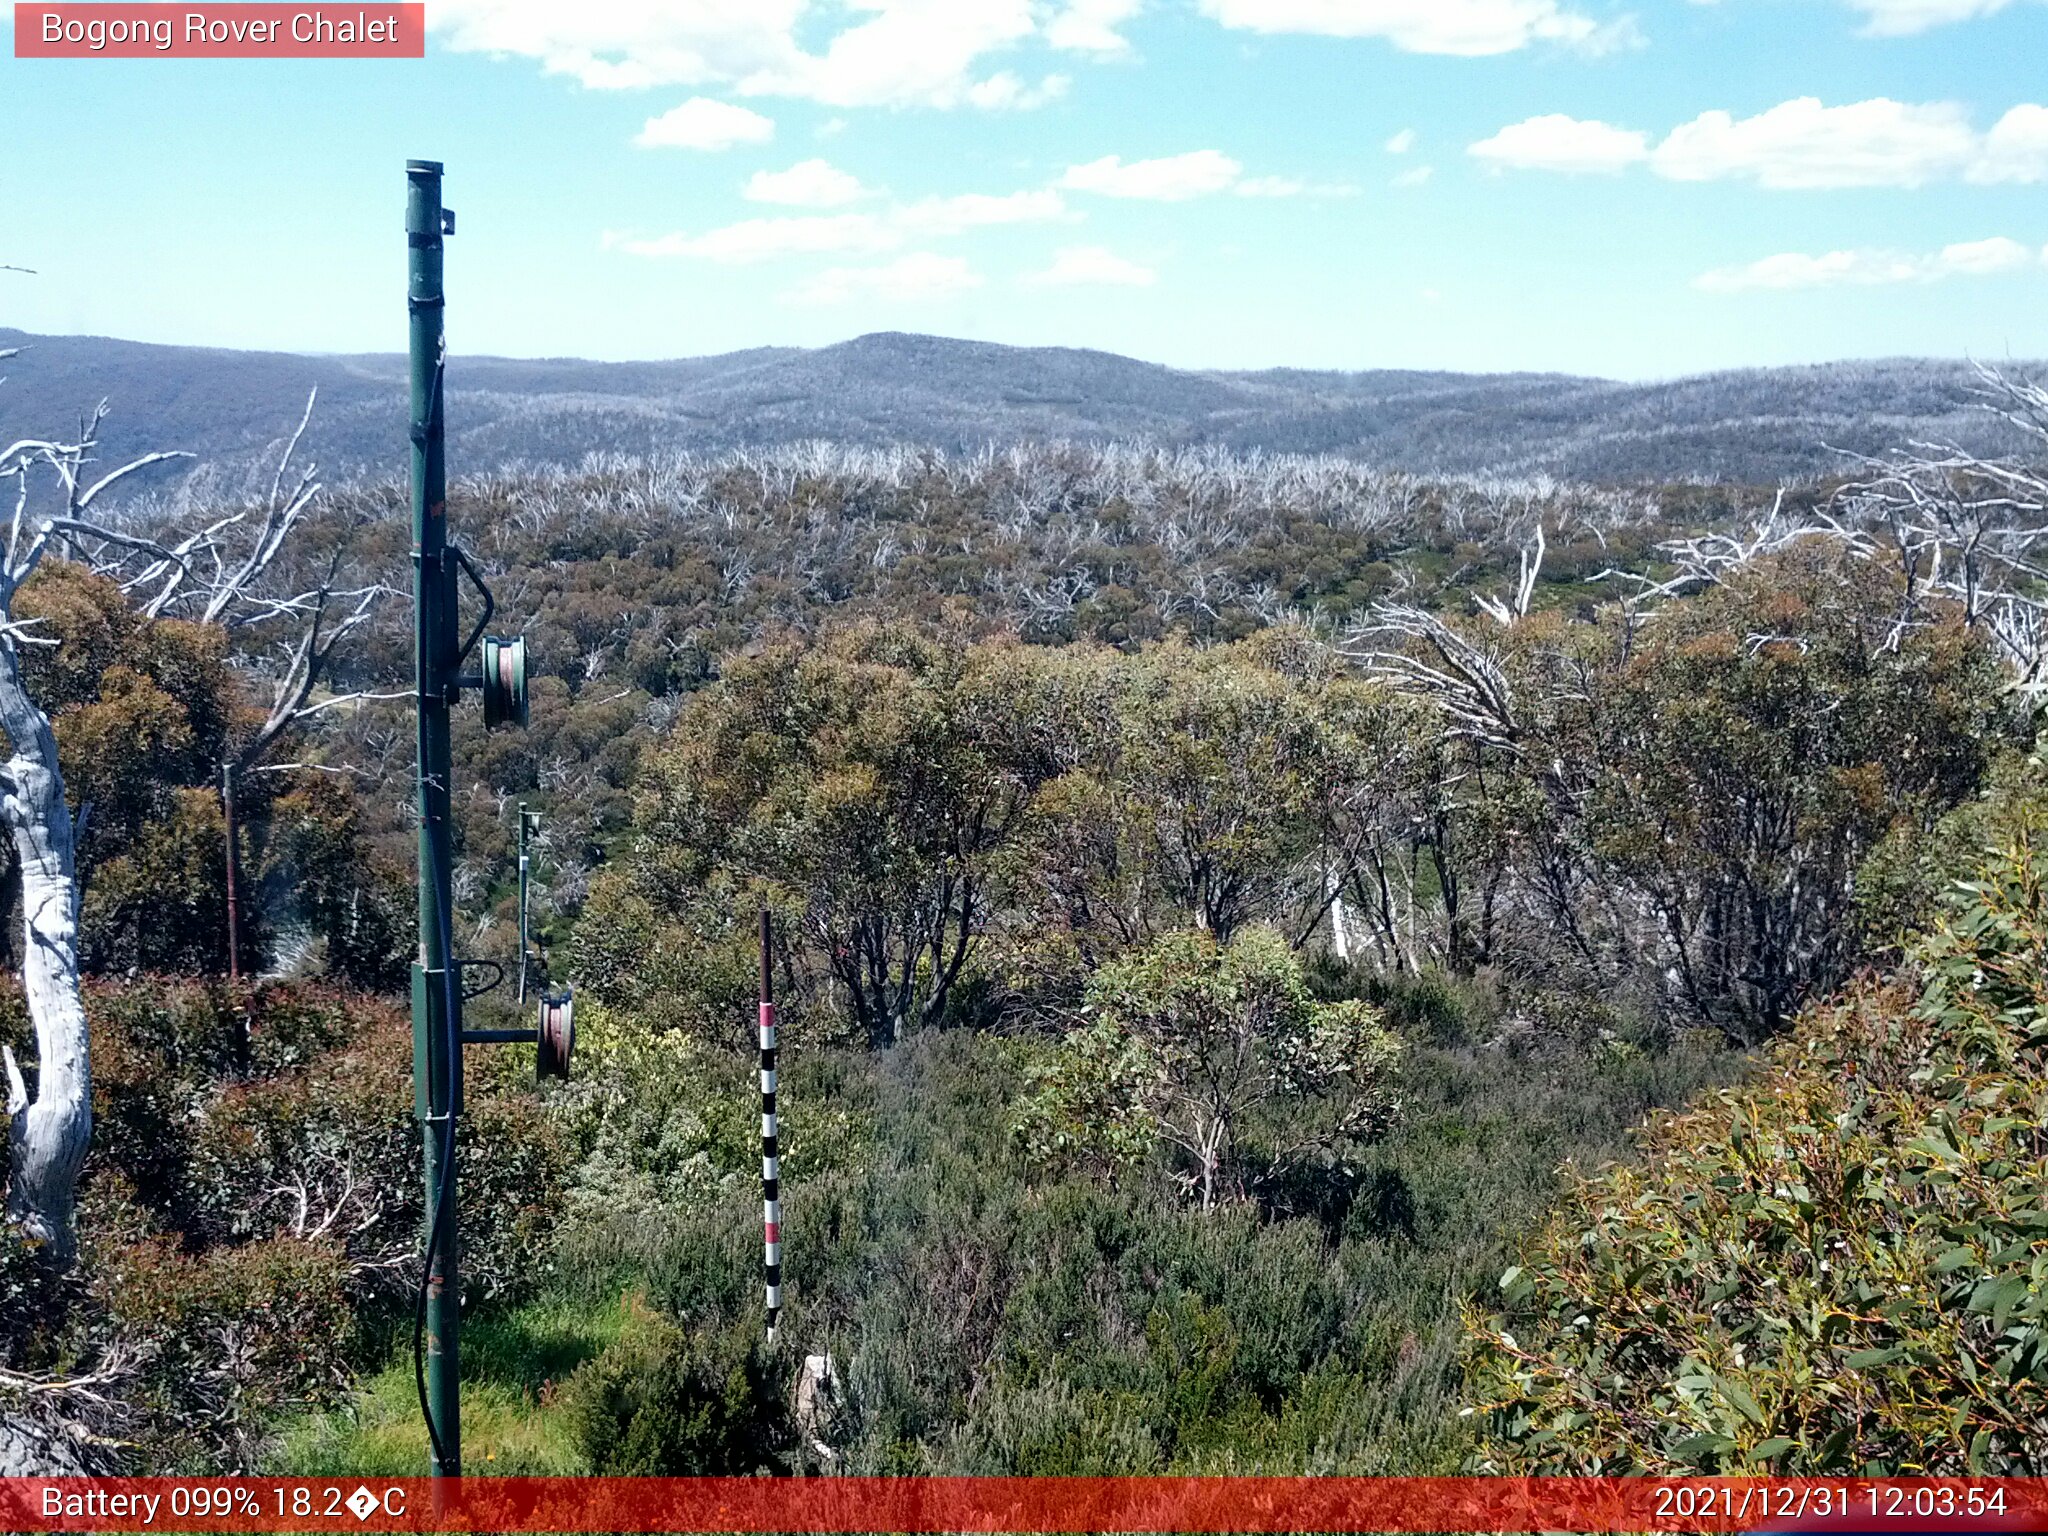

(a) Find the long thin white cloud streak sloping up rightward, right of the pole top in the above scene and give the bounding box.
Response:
[604,190,1069,266]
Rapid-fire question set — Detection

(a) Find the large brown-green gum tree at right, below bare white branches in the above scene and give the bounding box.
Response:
[1475,543,2007,1042]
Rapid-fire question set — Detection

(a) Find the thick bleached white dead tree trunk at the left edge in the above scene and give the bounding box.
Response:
[0,643,92,1266]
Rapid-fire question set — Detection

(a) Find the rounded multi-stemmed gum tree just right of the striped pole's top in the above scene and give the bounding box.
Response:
[606,627,1032,1044]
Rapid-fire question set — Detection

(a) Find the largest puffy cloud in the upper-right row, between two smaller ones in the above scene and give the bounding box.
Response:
[1653,96,1978,188]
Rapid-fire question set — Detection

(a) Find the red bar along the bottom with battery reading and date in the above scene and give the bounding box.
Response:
[0,1477,2048,1532]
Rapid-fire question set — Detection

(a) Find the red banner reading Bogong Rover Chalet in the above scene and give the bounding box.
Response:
[14,0,426,59]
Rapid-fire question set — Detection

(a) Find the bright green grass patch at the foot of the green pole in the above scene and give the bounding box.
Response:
[270,1296,637,1477]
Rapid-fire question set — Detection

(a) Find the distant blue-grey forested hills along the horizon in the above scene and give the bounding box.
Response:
[0,330,2025,483]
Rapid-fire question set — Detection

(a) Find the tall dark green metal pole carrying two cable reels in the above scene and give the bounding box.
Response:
[406,160,463,1477]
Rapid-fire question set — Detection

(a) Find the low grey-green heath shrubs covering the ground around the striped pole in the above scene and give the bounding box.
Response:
[524,1015,1726,1475]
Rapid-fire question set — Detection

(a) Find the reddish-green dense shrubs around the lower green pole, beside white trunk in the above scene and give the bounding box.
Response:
[0,979,565,1470]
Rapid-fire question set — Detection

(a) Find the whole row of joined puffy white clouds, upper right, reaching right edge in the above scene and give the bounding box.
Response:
[1468,96,2048,190]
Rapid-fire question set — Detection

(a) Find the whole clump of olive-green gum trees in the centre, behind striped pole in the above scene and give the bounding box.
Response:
[593,627,1411,1044]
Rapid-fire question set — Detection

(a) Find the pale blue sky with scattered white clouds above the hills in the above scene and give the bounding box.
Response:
[0,0,2048,379]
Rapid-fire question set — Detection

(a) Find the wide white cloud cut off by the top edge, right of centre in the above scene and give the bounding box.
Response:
[1202,0,1638,57]
